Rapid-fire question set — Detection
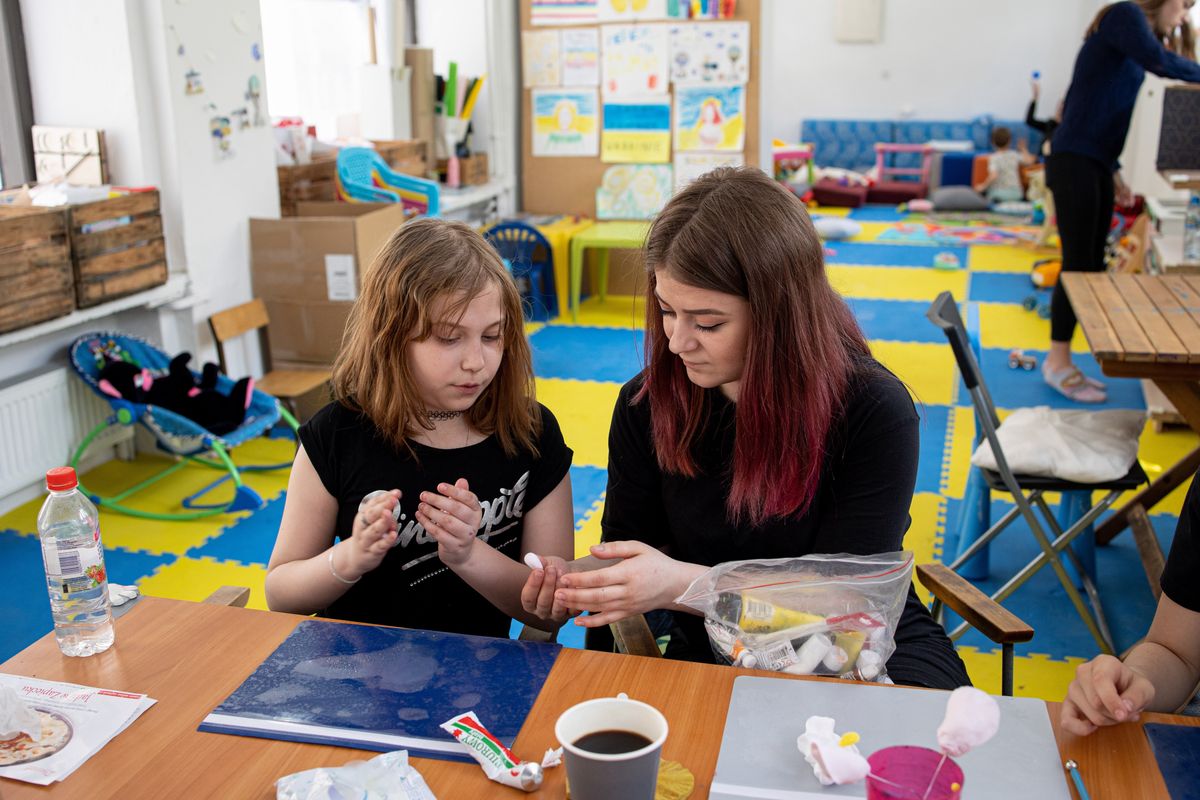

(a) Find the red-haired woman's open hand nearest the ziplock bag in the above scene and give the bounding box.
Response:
[554,542,707,627]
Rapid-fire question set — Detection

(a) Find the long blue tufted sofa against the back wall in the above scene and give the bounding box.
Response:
[800,116,1042,179]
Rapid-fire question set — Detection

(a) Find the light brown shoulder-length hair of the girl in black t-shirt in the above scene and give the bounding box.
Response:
[332,218,541,457]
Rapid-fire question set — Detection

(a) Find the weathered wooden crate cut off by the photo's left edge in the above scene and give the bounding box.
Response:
[0,206,76,333]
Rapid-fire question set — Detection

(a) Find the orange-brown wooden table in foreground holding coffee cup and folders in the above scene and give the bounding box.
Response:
[0,597,1200,800]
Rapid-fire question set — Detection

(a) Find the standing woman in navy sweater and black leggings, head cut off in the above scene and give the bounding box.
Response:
[1042,0,1200,403]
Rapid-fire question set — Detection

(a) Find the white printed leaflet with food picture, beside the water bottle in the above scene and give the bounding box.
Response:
[0,673,155,786]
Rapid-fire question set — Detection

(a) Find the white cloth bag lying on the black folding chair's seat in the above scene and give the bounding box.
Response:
[971,405,1146,483]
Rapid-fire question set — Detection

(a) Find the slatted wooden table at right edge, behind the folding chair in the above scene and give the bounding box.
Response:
[1062,272,1200,545]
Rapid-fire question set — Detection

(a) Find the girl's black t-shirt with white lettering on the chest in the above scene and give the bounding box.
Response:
[300,403,572,637]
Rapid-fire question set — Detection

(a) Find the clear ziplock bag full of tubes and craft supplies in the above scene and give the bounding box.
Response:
[676,551,912,681]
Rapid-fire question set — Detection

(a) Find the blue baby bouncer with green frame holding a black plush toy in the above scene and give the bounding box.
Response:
[71,331,300,521]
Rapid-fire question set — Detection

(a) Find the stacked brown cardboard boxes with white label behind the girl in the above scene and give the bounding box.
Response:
[250,203,404,365]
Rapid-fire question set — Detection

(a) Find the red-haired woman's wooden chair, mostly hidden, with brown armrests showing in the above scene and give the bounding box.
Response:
[608,564,1033,697]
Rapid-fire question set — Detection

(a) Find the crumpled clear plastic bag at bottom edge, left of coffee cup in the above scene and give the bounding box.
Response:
[275,750,437,800]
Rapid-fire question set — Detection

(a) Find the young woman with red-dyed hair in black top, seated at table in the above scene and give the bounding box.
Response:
[522,168,968,688]
